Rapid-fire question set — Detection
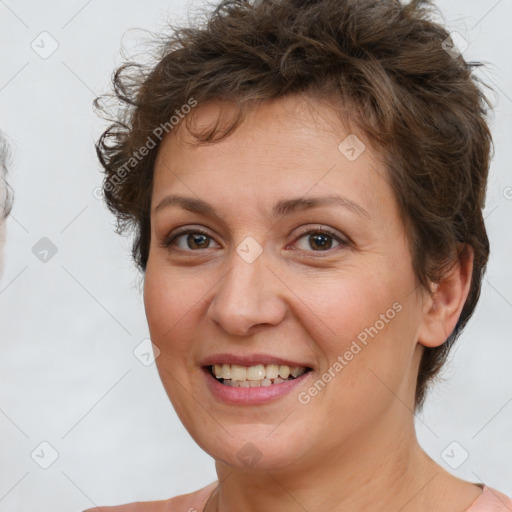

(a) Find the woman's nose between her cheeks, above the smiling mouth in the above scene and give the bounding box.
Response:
[208,247,286,336]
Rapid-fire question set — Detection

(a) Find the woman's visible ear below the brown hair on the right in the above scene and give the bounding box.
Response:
[418,244,474,347]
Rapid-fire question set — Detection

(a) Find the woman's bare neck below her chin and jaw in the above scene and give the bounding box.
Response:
[208,408,441,512]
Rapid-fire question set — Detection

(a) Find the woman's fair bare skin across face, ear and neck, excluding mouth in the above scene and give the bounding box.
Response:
[93,96,481,512]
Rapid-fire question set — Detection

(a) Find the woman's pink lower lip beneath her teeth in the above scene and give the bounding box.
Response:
[203,367,313,405]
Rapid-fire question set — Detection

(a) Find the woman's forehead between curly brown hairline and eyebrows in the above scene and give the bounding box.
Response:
[152,96,389,219]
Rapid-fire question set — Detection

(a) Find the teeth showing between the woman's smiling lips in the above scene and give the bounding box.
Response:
[208,364,311,388]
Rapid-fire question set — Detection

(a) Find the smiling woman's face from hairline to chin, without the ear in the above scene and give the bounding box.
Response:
[144,96,427,469]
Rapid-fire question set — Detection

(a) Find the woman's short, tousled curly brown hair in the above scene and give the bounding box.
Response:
[95,0,493,410]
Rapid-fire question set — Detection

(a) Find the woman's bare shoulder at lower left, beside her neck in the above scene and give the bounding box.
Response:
[83,482,217,512]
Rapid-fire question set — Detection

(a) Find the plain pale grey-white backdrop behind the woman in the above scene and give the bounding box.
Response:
[0,0,512,512]
